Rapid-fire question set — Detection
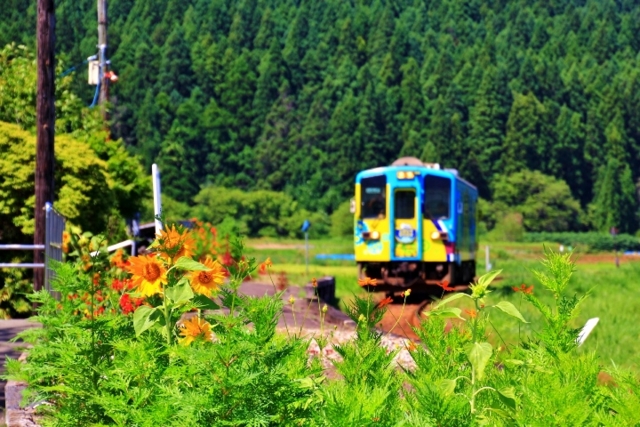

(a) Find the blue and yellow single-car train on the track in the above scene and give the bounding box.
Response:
[352,158,478,289]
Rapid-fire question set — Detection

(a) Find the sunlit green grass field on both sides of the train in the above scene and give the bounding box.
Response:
[247,239,640,370]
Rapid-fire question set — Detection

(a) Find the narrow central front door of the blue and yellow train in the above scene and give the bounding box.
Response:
[393,186,422,260]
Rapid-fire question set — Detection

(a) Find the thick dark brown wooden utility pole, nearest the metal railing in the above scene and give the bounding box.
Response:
[33,0,56,291]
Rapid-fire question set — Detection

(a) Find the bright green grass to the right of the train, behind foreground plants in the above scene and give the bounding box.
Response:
[470,244,640,370]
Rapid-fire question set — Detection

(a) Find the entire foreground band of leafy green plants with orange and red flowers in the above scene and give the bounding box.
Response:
[7,227,640,426]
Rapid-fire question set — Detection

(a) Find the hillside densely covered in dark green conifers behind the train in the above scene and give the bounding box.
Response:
[0,0,640,232]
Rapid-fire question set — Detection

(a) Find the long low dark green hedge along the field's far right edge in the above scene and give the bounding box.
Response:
[523,233,640,252]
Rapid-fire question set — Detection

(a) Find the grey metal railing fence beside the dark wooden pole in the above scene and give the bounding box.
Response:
[0,203,65,292]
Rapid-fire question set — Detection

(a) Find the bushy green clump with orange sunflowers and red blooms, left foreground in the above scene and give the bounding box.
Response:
[9,228,319,426]
